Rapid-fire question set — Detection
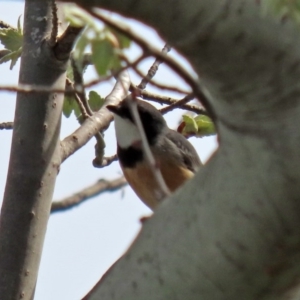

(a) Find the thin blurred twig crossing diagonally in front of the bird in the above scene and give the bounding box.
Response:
[126,93,170,201]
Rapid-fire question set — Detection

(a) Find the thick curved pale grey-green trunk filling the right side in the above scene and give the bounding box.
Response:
[58,0,300,300]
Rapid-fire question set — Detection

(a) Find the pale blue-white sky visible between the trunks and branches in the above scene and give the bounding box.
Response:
[0,0,217,300]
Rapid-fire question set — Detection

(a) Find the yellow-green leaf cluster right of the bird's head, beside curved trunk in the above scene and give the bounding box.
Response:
[177,115,216,137]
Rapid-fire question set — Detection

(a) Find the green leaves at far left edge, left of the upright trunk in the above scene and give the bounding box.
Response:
[0,16,23,70]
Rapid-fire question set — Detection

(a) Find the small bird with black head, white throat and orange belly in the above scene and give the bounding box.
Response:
[107,99,202,210]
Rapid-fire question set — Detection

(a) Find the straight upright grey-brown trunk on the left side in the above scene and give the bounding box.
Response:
[0,0,66,300]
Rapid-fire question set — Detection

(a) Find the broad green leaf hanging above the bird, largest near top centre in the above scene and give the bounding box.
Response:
[92,39,116,76]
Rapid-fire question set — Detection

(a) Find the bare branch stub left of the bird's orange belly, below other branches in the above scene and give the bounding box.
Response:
[51,176,127,213]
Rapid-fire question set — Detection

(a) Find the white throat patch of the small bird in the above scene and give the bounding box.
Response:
[114,114,141,148]
